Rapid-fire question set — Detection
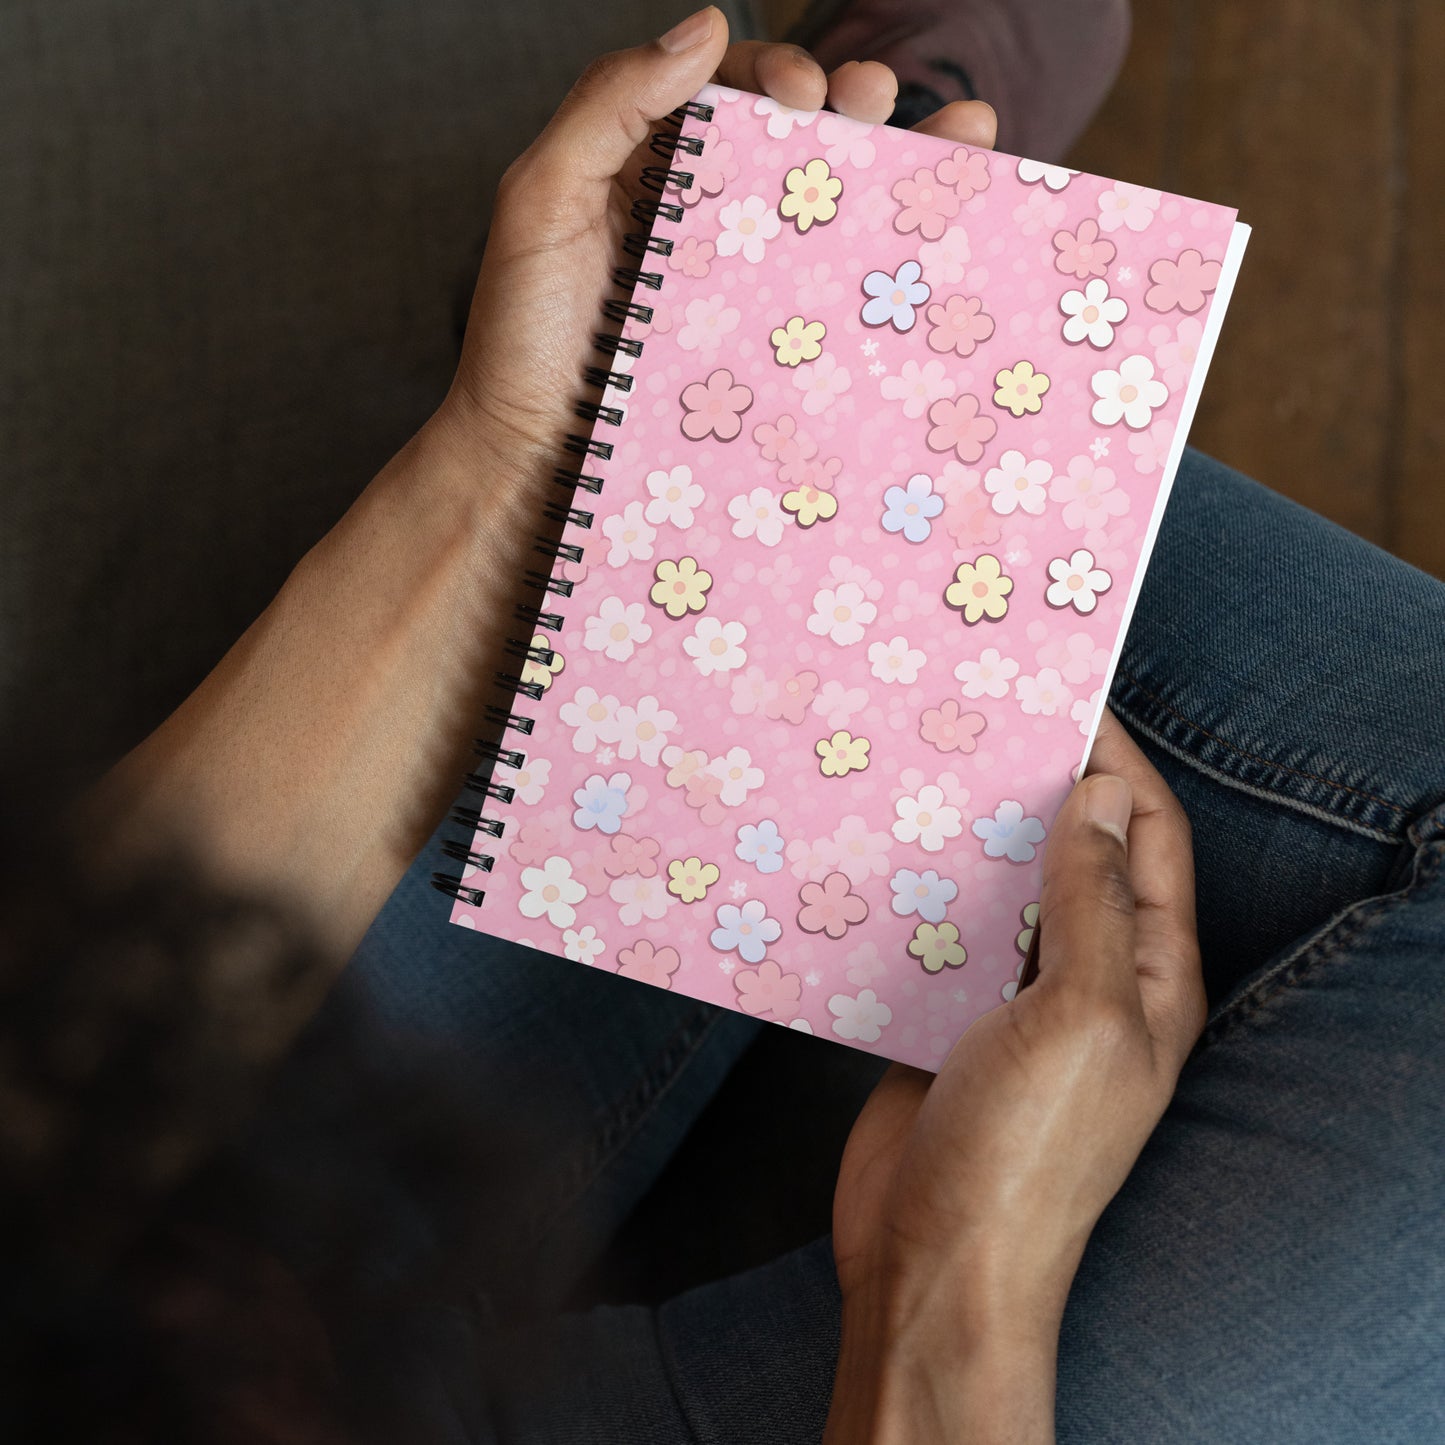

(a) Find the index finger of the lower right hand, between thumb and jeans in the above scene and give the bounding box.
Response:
[1088,708,1208,1064]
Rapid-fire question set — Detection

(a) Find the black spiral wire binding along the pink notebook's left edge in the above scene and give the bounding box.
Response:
[432,100,712,907]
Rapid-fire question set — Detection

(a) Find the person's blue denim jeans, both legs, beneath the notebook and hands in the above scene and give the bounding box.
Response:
[328,452,1445,1445]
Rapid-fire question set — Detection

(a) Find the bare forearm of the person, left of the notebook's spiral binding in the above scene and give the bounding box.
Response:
[91,407,539,962]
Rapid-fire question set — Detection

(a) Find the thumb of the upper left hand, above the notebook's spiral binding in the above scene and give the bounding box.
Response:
[523,6,727,211]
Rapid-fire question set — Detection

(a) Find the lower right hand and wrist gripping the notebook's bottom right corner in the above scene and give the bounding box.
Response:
[828,712,1207,1445]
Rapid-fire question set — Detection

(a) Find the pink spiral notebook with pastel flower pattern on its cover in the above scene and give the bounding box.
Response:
[436,85,1248,1069]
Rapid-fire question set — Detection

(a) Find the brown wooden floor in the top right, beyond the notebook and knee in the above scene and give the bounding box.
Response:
[776,0,1445,577]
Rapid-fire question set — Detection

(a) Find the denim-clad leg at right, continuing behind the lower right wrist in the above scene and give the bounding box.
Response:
[462,454,1445,1445]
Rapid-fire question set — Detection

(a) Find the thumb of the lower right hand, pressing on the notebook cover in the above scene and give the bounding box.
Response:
[1039,773,1140,1013]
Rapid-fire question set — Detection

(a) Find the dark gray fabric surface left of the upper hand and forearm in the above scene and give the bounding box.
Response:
[0,0,757,786]
